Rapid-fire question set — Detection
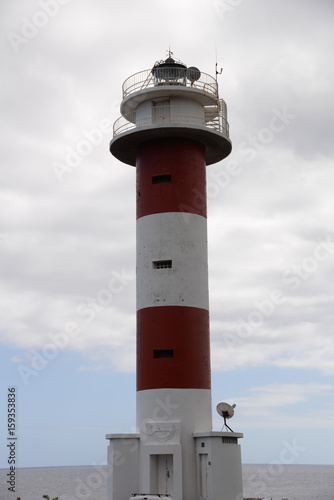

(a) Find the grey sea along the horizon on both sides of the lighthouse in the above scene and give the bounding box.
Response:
[0,464,334,500]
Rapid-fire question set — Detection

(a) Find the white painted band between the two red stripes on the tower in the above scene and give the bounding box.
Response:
[137,212,209,310]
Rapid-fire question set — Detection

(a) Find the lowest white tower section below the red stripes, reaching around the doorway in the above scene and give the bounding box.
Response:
[137,389,212,500]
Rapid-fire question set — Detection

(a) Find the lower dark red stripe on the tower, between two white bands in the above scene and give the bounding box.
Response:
[137,306,211,391]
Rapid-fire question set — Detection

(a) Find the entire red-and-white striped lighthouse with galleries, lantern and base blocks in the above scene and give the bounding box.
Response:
[106,54,243,500]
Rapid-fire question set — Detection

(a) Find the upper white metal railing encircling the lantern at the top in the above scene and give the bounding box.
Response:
[122,67,218,99]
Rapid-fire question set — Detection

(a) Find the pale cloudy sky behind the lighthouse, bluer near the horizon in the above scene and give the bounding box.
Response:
[0,0,334,476]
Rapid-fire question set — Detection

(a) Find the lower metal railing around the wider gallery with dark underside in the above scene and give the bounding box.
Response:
[113,99,229,137]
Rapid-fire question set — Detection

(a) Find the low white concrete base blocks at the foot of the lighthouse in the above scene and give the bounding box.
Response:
[106,428,243,500]
